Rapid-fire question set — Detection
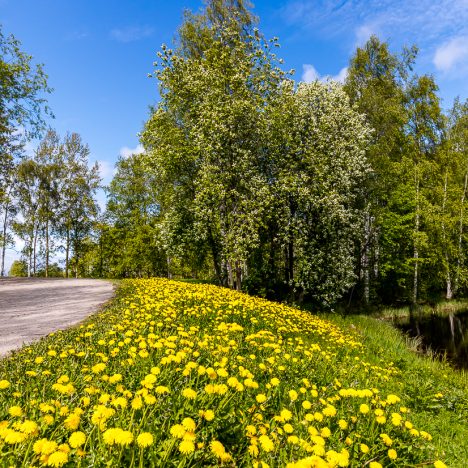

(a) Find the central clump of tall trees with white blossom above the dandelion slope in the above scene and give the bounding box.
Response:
[142,2,369,303]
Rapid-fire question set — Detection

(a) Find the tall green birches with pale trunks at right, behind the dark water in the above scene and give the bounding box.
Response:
[345,37,466,304]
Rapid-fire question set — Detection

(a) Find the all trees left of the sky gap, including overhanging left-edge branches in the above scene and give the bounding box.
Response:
[0,29,100,277]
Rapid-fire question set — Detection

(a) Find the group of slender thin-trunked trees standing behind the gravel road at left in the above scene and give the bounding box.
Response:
[1,130,101,278]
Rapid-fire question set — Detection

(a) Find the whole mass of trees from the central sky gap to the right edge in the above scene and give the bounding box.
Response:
[91,0,468,305]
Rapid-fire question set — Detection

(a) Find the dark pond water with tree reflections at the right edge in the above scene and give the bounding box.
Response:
[395,310,468,369]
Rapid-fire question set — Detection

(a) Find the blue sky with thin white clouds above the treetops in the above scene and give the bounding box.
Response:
[0,0,468,270]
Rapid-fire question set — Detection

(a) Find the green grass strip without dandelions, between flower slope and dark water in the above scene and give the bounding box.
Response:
[326,315,468,468]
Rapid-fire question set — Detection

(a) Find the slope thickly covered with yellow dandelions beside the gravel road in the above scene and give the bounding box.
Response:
[0,279,445,468]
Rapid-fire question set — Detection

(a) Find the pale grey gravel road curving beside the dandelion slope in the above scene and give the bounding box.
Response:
[0,278,114,356]
